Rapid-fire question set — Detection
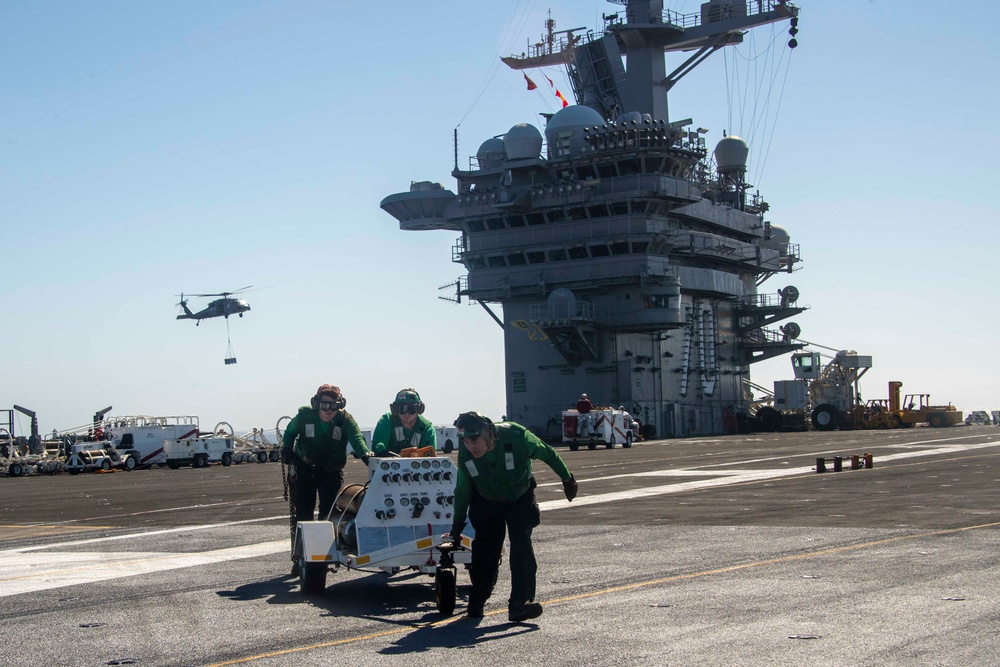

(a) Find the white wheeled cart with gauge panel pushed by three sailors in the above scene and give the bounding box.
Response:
[294,447,472,616]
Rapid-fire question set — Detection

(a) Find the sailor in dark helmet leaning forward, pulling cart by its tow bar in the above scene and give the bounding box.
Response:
[451,412,577,623]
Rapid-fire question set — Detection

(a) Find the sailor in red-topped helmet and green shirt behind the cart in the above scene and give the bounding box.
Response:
[281,384,371,576]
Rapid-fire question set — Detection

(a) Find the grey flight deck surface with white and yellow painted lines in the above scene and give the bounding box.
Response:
[0,427,1000,665]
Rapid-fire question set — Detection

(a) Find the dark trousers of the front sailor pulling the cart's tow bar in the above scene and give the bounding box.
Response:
[469,478,542,607]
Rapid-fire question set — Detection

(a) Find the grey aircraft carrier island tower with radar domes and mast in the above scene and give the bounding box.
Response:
[381,0,803,438]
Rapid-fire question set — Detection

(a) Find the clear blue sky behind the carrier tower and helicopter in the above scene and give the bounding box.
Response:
[0,0,1000,434]
